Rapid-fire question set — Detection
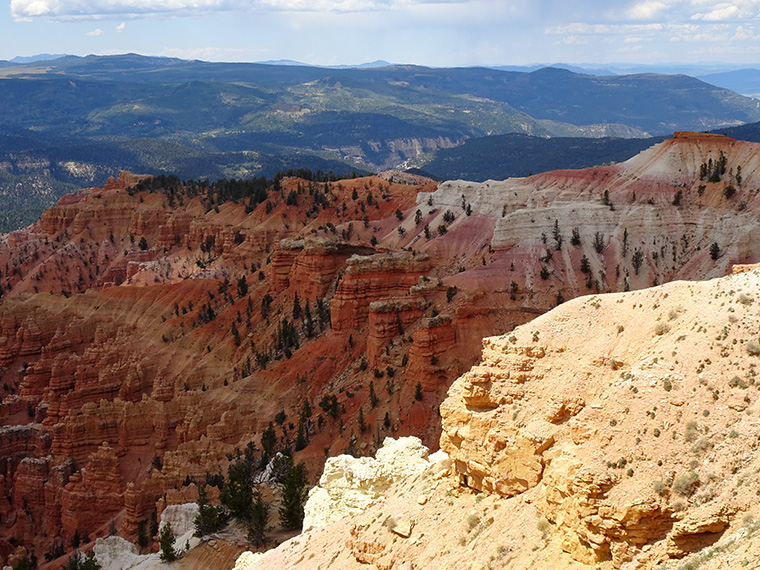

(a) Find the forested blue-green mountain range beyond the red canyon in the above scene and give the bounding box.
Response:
[0,54,760,230]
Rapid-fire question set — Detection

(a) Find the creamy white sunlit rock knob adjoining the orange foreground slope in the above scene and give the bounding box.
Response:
[303,436,447,529]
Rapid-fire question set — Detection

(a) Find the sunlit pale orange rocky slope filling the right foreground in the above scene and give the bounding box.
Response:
[248,270,760,570]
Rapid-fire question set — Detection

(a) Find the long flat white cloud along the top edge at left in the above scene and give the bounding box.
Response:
[10,0,471,21]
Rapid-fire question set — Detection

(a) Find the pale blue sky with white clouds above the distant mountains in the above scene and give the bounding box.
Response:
[0,0,760,67]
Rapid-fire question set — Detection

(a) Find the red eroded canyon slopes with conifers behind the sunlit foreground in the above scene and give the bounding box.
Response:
[0,134,760,558]
